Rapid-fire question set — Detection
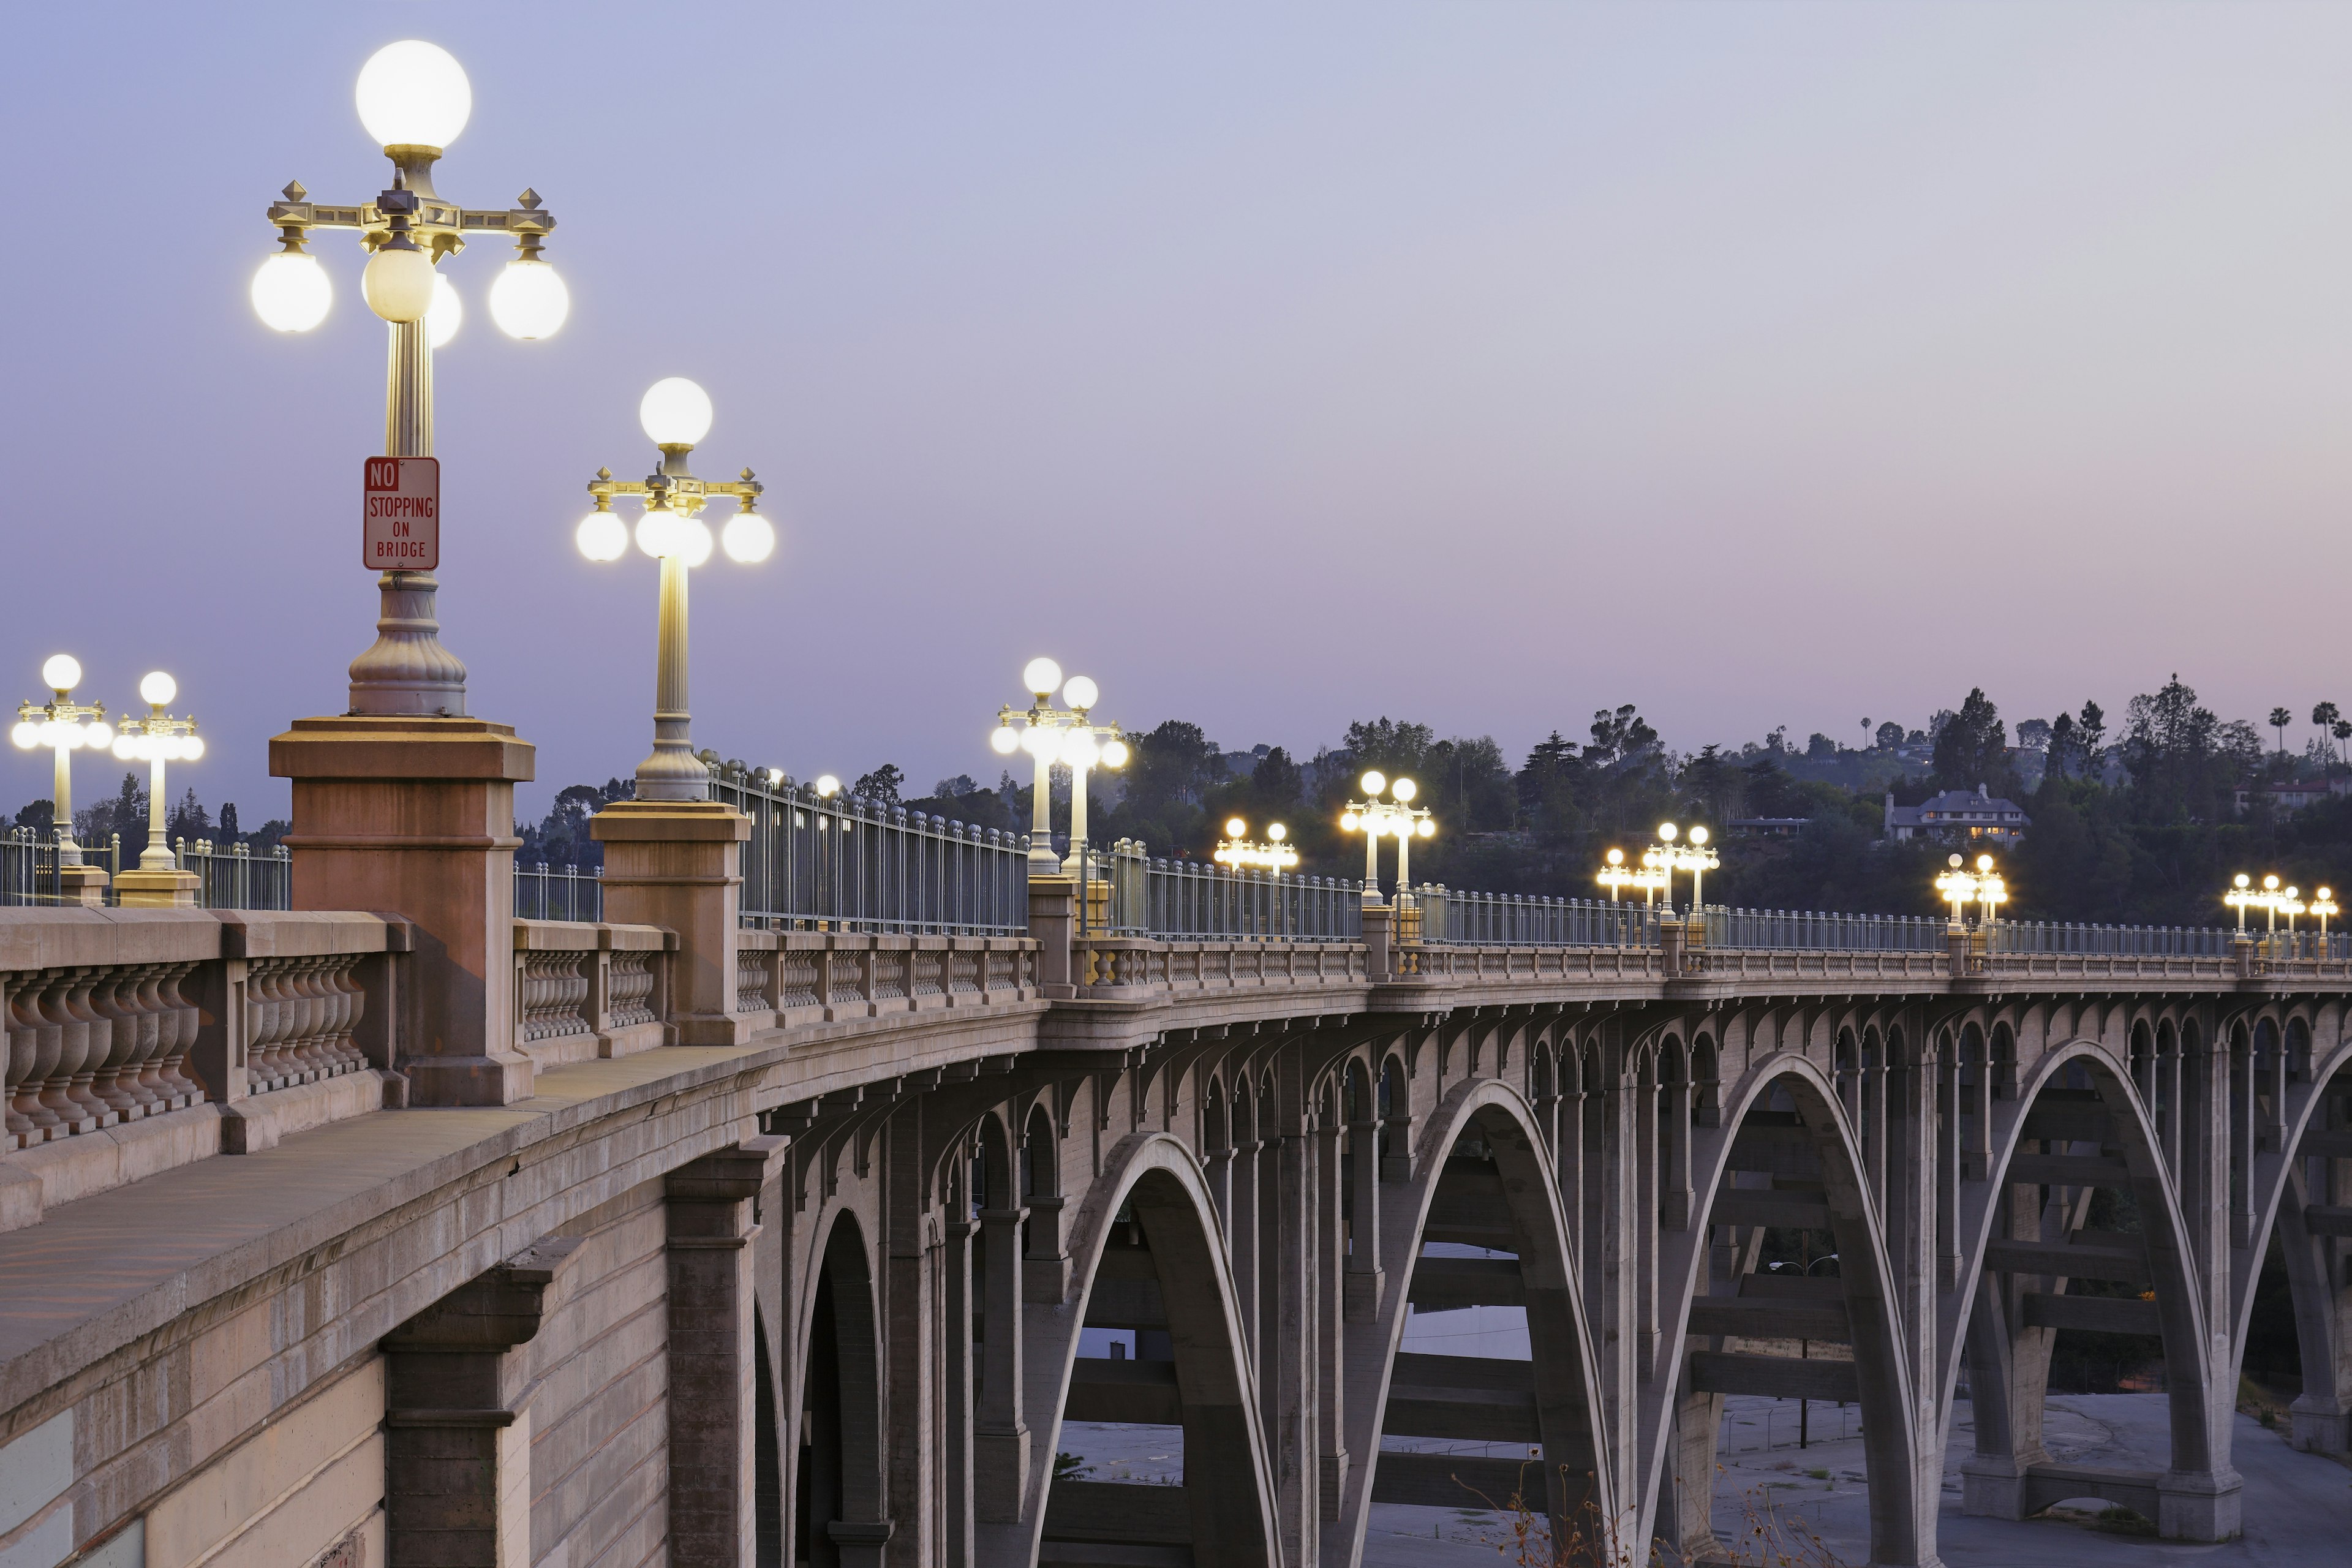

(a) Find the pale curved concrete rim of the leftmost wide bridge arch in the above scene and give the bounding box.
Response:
[1019,1133,1280,1568]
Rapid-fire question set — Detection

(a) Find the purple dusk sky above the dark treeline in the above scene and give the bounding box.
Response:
[0,2,2352,825]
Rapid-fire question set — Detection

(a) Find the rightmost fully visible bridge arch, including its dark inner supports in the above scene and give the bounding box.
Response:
[1938,1025,2237,1540]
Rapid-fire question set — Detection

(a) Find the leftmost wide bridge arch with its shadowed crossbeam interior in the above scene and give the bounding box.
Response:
[1011,1133,1280,1568]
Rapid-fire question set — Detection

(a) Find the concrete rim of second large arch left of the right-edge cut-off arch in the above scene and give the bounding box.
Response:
[1632,1053,1938,1563]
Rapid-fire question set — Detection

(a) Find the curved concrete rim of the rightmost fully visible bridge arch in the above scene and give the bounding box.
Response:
[1938,1039,2232,1504]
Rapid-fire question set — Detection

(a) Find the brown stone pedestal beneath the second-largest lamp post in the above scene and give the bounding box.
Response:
[588,799,755,1046]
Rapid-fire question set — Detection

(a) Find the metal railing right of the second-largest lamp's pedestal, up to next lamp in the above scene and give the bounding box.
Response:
[710,766,1028,936]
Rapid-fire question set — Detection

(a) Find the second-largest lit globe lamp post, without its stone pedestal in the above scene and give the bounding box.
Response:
[574,376,776,799]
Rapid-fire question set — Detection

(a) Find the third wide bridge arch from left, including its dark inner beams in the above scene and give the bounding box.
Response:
[1630,1053,1938,1563]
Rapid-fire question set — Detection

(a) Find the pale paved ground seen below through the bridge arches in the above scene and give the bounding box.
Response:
[1061,1394,2352,1568]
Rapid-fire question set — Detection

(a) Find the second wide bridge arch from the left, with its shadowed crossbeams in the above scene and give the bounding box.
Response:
[1324,1077,1616,1563]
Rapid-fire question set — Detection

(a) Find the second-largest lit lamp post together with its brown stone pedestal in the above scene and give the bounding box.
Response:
[588,376,776,1046]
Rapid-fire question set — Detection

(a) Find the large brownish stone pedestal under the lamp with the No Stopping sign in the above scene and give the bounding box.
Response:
[271,715,534,1105]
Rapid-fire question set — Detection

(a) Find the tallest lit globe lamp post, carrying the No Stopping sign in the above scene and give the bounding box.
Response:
[252,40,571,717]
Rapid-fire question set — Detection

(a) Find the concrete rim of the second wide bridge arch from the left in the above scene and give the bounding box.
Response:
[1324,1079,1618,1563]
